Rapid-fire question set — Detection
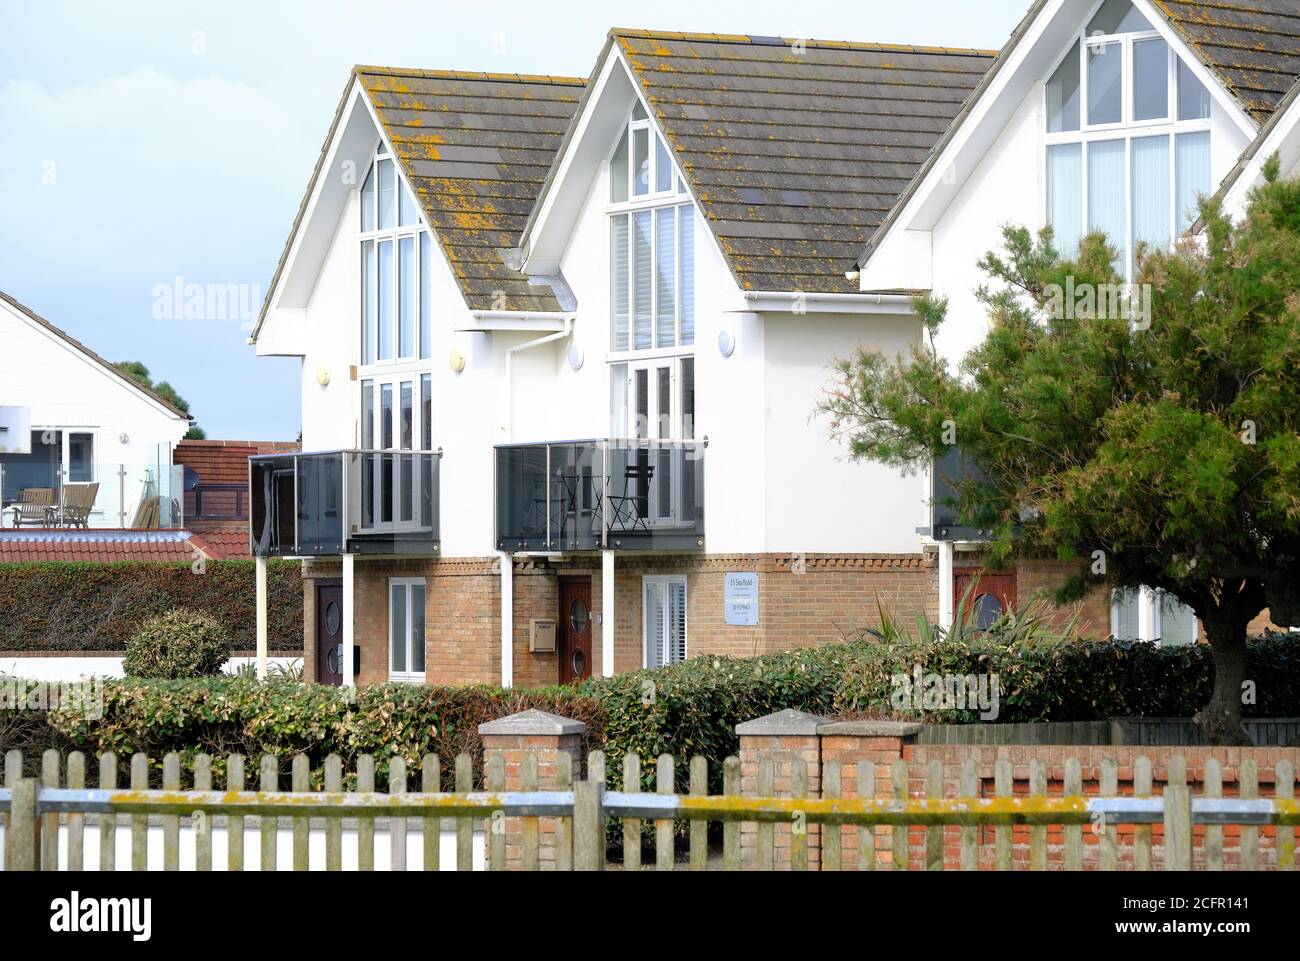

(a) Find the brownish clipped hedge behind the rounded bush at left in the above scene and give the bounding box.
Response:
[0,560,303,657]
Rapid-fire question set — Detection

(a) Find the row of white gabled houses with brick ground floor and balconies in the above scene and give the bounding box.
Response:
[251,0,1300,684]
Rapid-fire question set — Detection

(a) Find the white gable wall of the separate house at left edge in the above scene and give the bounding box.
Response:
[0,300,189,527]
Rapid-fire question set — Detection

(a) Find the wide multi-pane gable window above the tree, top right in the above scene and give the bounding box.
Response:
[1045,0,1210,280]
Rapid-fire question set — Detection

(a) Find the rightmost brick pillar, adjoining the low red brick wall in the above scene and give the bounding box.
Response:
[818,720,922,871]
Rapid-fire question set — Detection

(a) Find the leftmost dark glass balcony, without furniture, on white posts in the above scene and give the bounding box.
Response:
[248,450,442,557]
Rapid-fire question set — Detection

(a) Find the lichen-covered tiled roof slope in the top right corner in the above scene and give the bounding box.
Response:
[1152,0,1300,125]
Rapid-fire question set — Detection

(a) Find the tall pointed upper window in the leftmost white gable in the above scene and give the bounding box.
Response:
[360,144,433,365]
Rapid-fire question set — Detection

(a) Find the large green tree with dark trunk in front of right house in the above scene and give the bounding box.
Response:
[819,160,1300,744]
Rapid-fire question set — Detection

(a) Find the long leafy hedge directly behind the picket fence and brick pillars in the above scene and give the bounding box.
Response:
[0,635,1300,787]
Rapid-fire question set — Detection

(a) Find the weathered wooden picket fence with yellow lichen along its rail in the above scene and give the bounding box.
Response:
[0,750,1300,871]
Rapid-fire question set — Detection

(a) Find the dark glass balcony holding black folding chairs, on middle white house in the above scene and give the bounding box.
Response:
[497,440,705,553]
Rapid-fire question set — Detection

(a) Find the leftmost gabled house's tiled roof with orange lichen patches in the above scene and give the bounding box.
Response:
[356,66,586,311]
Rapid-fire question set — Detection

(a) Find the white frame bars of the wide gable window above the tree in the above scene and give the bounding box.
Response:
[1043,3,1213,280]
